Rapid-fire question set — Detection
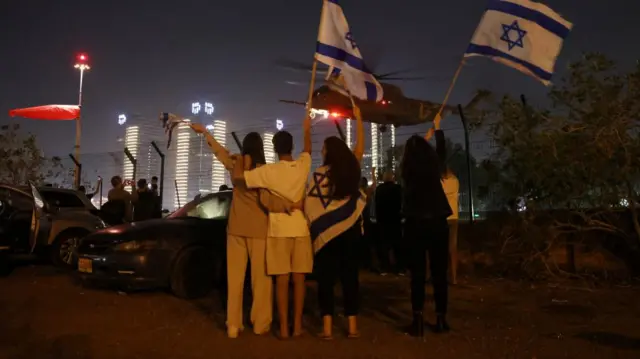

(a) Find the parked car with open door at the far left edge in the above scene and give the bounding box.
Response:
[0,184,106,267]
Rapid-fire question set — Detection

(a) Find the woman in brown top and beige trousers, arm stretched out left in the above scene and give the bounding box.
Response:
[190,124,296,338]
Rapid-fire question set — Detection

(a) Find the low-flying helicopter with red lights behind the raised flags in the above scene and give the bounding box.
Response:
[280,61,490,131]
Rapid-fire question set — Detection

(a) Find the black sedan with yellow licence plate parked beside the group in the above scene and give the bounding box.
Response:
[78,191,232,298]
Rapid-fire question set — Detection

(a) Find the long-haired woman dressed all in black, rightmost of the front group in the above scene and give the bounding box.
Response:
[401,136,452,337]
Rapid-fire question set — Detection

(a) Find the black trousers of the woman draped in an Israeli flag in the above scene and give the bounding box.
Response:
[315,222,361,316]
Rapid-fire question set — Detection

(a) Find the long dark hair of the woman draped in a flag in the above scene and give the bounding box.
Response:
[323,136,360,199]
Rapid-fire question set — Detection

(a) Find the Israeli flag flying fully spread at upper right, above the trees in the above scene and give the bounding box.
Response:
[464,0,573,85]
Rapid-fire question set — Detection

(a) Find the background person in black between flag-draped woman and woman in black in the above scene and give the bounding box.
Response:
[374,171,406,275]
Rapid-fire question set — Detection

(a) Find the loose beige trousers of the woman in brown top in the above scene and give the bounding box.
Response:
[227,234,273,334]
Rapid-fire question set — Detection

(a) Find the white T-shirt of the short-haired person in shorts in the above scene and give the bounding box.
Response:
[244,152,311,237]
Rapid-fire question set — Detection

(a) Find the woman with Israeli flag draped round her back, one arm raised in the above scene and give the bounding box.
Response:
[304,107,366,340]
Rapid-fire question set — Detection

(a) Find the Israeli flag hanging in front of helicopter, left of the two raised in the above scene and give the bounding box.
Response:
[316,0,383,101]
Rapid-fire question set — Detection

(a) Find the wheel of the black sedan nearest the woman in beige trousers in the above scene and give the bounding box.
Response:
[170,246,215,299]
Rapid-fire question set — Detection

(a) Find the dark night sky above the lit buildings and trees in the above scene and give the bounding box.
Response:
[0,0,640,154]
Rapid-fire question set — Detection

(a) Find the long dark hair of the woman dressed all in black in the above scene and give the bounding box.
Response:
[400,135,445,189]
